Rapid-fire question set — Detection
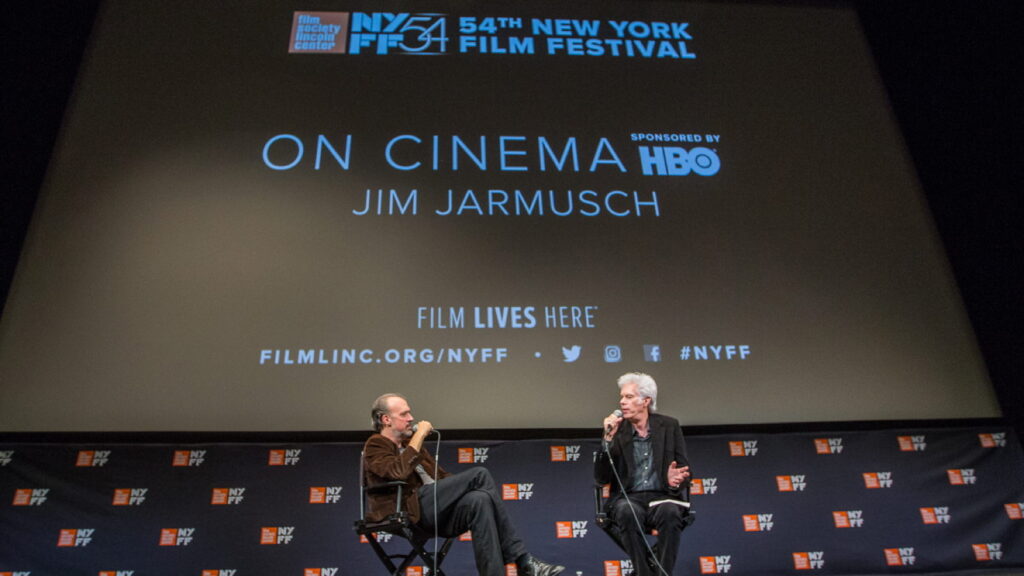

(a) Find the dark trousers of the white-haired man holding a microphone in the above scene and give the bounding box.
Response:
[608,492,685,576]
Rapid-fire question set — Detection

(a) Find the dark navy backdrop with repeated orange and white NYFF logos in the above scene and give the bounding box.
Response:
[0,425,1024,576]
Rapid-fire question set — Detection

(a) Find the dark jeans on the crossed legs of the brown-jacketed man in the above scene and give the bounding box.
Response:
[418,467,526,576]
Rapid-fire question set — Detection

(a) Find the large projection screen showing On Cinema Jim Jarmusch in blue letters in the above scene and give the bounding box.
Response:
[0,0,999,431]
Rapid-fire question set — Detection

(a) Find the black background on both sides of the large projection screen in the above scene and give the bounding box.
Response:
[0,0,1024,431]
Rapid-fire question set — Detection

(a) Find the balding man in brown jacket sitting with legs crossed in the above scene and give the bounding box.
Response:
[362,394,565,576]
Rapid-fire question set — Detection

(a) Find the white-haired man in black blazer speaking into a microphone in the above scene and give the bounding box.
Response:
[594,372,690,576]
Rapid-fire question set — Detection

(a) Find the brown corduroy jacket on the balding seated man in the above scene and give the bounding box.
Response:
[362,434,449,523]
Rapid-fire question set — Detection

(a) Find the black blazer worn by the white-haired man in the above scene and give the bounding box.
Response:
[594,412,690,502]
